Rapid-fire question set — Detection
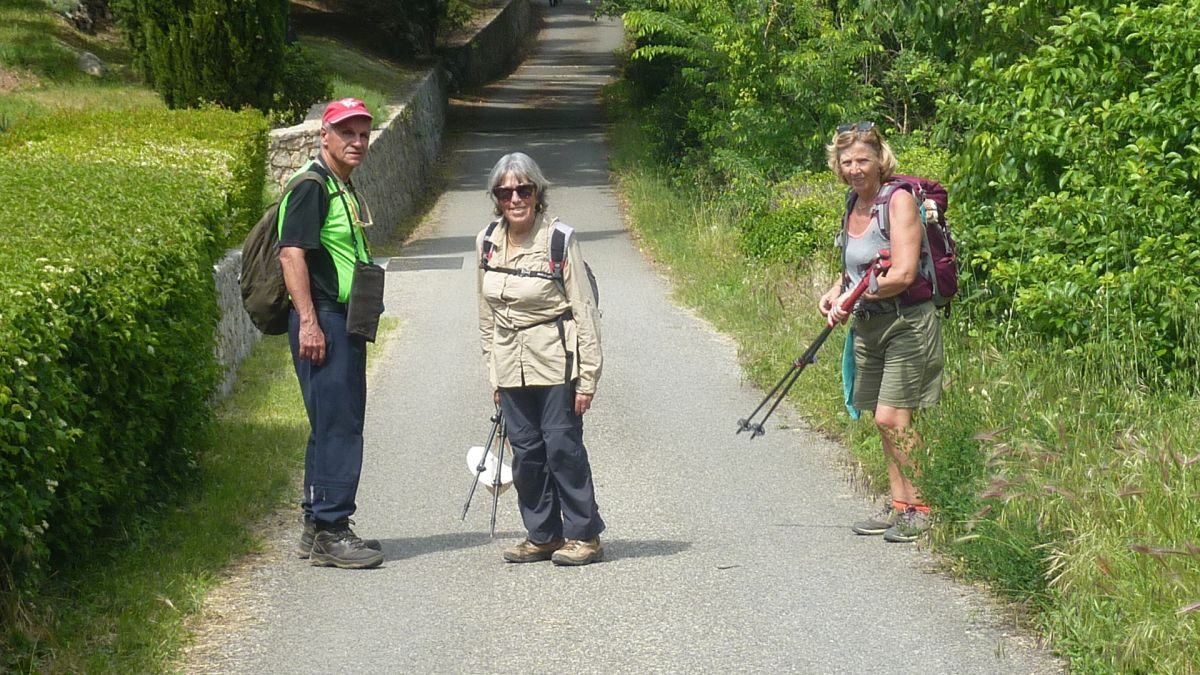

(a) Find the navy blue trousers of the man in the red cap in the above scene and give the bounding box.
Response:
[288,310,367,525]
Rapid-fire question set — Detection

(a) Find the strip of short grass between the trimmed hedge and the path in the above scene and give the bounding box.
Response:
[0,318,398,673]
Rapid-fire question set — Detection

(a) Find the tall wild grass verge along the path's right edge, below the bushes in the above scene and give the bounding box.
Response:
[613,109,1200,673]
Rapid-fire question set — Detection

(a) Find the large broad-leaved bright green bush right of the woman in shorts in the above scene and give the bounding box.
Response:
[946,2,1200,371]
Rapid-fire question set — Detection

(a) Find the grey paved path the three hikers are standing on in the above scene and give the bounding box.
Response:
[198,0,1056,674]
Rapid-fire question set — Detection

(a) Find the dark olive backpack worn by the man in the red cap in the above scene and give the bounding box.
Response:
[238,171,325,335]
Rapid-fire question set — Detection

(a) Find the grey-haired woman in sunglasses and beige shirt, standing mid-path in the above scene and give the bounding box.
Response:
[475,153,605,565]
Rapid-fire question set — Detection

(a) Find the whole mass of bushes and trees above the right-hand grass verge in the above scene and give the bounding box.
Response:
[607,0,1200,386]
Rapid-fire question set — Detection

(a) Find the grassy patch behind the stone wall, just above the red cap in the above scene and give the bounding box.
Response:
[300,37,416,124]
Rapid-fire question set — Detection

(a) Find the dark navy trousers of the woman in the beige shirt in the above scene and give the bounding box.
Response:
[500,384,604,544]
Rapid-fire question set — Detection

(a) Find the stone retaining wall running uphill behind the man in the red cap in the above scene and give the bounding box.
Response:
[212,0,533,396]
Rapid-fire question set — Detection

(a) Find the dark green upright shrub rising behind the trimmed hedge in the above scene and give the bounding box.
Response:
[114,0,300,110]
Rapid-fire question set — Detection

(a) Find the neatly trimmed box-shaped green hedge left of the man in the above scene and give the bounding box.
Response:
[0,105,265,589]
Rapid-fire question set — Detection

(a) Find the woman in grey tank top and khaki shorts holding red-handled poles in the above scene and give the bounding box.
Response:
[820,121,943,542]
